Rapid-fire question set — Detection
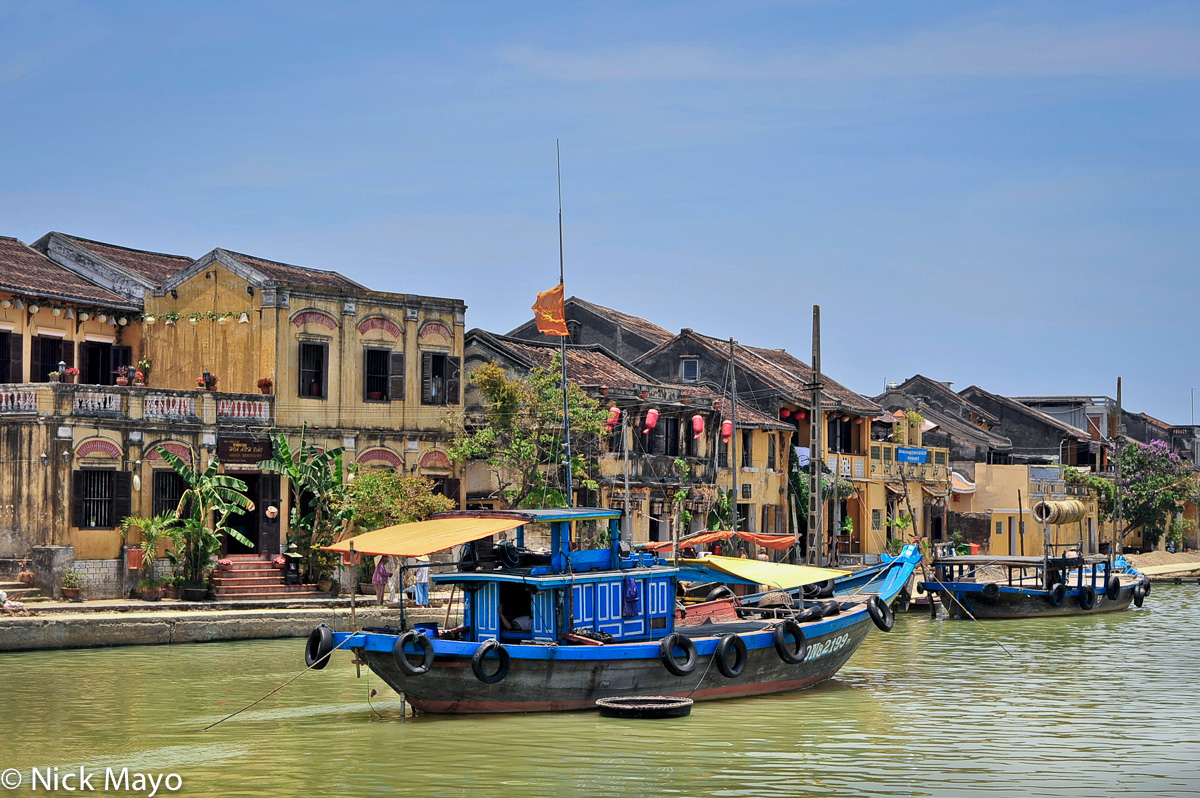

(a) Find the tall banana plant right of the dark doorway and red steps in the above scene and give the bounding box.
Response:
[258,425,346,582]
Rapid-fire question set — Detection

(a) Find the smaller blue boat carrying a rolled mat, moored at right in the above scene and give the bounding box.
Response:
[918,552,1150,620]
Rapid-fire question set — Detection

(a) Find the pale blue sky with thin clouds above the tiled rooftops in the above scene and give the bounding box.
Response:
[0,0,1200,424]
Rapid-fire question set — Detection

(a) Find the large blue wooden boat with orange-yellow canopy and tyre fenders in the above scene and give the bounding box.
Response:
[305,509,920,713]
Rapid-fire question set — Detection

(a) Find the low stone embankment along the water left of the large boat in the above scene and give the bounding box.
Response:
[0,599,460,652]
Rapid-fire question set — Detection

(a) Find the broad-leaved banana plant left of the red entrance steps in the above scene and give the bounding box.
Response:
[158,446,254,587]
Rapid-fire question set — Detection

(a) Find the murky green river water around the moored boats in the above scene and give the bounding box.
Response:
[0,584,1200,798]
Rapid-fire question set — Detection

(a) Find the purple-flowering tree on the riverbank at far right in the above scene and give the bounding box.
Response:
[1117,440,1195,546]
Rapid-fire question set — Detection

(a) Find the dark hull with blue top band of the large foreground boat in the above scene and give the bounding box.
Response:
[356,610,872,713]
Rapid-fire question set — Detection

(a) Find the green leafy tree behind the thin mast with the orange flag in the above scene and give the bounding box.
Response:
[449,354,606,508]
